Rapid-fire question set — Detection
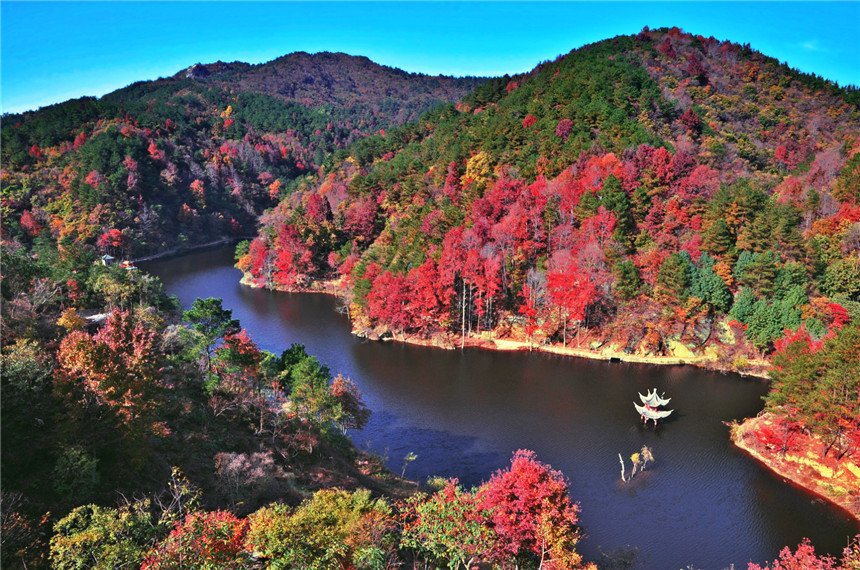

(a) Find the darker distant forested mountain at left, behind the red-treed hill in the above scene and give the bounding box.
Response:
[2,53,483,257]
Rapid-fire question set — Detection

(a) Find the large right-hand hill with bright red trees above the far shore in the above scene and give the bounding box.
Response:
[240,28,860,370]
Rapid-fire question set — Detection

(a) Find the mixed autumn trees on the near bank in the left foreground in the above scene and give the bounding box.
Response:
[0,249,596,569]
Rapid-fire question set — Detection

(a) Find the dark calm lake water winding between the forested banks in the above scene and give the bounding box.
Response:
[145,248,860,569]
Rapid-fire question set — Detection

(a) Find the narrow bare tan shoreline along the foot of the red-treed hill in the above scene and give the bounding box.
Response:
[239,274,768,380]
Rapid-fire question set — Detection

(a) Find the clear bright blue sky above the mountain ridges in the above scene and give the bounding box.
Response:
[0,0,860,113]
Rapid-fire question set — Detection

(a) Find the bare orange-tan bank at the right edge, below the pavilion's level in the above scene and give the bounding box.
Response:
[732,412,860,520]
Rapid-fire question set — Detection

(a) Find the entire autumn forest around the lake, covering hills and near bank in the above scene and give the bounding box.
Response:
[0,28,860,568]
